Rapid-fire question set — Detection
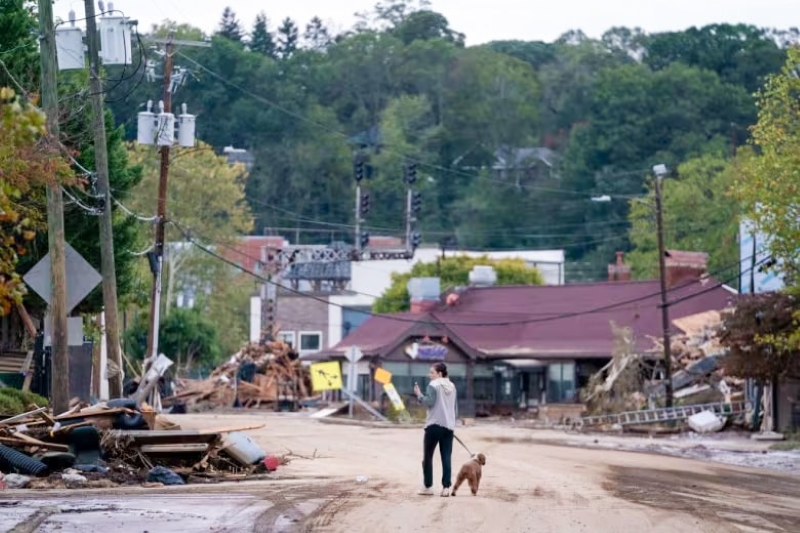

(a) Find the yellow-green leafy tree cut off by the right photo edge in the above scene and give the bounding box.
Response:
[735,47,800,283]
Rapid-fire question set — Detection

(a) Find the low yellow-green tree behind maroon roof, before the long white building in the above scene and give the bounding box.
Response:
[372,255,544,313]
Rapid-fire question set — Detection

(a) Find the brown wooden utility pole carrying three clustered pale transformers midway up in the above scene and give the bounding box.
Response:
[146,31,174,360]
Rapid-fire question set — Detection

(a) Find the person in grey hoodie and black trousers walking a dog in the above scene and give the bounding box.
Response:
[414,363,458,497]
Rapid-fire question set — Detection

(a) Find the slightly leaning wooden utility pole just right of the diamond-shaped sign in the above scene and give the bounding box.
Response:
[84,0,122,398]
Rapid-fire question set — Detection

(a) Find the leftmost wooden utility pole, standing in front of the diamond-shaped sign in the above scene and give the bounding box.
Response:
[39,0,69,413]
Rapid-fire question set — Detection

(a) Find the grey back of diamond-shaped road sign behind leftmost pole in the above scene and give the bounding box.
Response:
[22,242,103,313]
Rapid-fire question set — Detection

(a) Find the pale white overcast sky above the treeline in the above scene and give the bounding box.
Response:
[54,0,800,45]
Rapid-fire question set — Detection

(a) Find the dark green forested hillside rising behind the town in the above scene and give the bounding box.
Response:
[100,2,797,279]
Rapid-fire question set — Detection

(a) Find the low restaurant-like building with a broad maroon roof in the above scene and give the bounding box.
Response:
[313,251,736,411]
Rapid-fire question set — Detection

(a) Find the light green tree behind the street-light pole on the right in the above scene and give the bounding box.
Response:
[628,155,739,280]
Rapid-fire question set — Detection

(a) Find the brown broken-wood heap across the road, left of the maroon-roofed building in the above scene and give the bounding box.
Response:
[163,342,312,410]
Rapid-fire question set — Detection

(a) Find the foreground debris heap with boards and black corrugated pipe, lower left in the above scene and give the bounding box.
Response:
[0,398,286,488]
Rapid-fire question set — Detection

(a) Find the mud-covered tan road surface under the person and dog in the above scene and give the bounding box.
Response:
[0,413,800,533]
